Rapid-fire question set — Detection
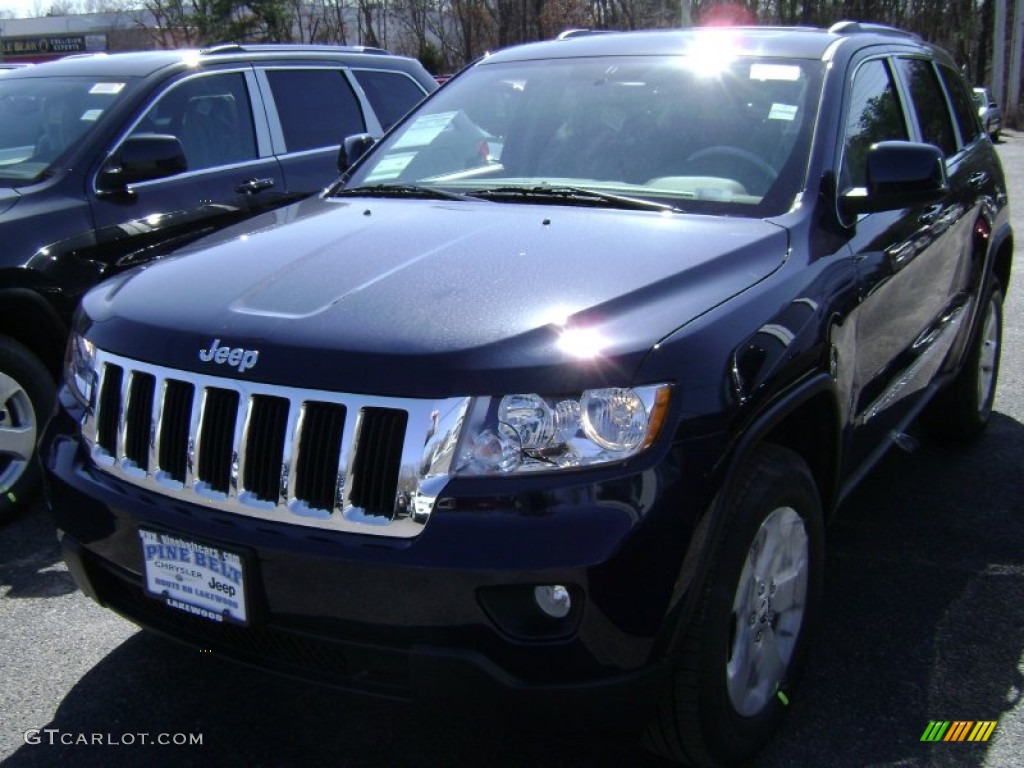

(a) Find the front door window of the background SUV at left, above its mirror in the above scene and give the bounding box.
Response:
[132,72,256,171]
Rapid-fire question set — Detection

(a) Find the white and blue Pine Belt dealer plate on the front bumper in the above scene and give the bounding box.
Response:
[138,529,248,624]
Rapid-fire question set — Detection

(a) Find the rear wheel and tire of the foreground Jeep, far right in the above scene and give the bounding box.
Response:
[921,278,1002,441]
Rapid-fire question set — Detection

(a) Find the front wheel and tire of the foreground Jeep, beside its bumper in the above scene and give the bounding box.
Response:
[644,444,824,766]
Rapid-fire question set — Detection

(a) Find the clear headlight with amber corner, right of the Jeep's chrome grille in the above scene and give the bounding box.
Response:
[455,384,672,475]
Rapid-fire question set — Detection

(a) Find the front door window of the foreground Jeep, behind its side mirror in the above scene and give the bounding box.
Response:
[842,59,908,189]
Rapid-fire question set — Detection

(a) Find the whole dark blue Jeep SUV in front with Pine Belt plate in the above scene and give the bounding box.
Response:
[43,23,1013,763]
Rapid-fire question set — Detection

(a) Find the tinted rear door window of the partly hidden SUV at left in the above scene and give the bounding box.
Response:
[266,70,366,152]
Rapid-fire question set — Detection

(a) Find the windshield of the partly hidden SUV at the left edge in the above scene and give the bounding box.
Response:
[0,75,137,186]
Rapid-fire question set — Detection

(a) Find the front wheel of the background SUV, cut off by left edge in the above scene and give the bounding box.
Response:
[0,336,56,524]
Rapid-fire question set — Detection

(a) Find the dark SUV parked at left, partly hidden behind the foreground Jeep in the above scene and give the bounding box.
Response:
[0,45,436,521]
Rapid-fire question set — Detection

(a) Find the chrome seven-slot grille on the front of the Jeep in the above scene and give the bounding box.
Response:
[82,350,468,537]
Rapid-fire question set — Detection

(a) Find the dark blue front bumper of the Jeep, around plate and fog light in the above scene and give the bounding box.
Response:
[43,411,704,729]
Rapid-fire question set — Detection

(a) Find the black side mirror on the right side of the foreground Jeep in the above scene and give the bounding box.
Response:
[840,141,949,215]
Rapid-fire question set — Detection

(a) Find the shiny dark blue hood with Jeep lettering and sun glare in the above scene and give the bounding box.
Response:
[84,198,787,397]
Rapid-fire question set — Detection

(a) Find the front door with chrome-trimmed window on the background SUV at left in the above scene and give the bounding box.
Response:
[89,65,288,266]
